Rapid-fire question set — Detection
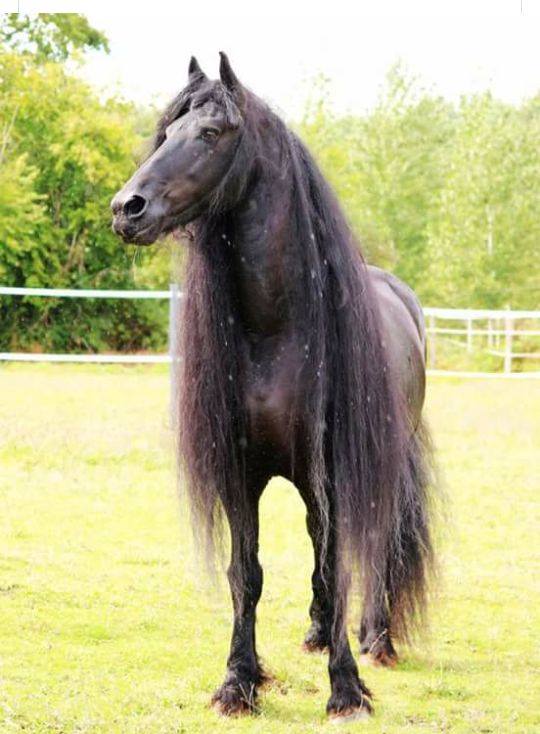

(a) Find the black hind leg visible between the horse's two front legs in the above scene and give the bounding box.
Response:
[303,497,333,652]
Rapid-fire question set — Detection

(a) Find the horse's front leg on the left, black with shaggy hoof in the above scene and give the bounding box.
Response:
[212,483,265,715]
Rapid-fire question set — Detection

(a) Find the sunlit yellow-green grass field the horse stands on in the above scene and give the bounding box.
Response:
[0,365,540,734]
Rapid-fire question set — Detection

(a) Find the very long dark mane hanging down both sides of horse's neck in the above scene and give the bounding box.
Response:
[174,82,432,638]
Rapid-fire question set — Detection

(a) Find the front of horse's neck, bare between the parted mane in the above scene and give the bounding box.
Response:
[228,162,294,339]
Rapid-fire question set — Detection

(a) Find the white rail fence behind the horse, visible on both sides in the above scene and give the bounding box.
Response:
[0,285,540,378]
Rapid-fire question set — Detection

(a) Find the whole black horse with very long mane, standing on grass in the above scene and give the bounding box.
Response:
[112,54,433,720]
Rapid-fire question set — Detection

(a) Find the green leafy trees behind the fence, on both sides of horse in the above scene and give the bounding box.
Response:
[0,14,540,351]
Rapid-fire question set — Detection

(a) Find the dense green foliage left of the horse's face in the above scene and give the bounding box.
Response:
[0,16,166,351]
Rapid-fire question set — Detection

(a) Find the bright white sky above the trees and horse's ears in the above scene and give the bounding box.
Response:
[4,0,540,118]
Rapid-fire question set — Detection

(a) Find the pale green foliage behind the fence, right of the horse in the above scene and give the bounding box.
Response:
[300,65,540,308]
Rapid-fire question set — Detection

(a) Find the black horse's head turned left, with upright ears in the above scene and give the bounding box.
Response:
[111,52,245,245]
